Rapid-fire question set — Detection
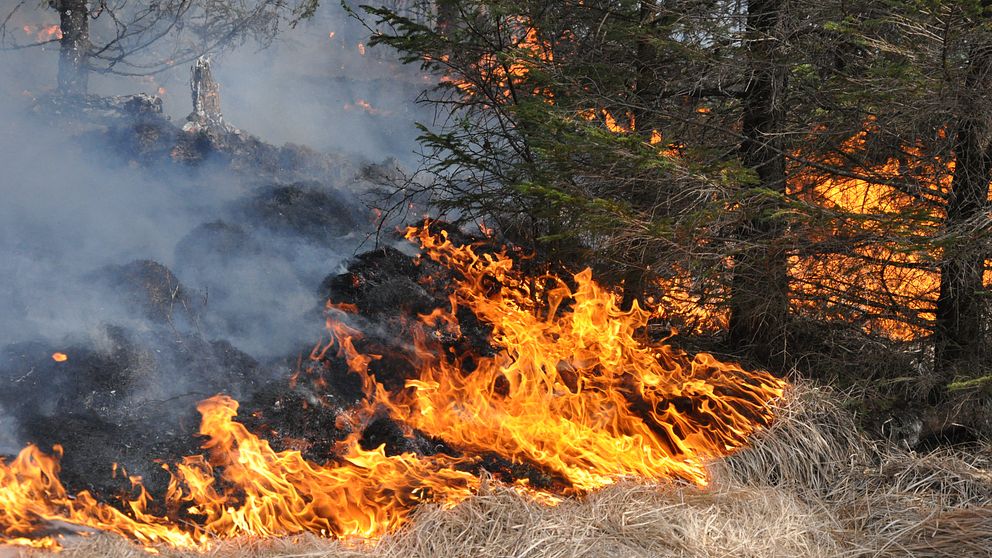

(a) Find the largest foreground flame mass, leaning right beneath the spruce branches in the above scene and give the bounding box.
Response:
[338,225,784,491]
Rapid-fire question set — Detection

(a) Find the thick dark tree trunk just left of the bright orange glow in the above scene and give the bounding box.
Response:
[729,0,789,366]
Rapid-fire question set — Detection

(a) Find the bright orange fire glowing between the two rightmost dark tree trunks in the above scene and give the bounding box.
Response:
[788,121,954,340]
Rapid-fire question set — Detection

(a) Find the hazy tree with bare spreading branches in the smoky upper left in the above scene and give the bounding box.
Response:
[0,0,318,95]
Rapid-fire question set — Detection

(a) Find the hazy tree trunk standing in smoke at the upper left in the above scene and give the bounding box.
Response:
[52,0,90,95]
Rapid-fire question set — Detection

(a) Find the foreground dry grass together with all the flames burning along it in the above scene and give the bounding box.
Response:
[7,229,992,557]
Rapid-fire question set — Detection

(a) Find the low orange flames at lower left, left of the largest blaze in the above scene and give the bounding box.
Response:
[0,396,479,550]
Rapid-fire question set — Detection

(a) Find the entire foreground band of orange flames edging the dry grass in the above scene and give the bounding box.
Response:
[0,227,785,551]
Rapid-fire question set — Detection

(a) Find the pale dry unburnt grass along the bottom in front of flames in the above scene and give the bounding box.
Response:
[11,387,992,558]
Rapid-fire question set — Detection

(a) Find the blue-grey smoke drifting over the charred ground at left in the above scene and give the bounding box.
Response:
[0,3,424,452]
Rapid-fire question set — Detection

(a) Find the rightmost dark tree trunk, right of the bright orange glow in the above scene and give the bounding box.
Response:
[934,40,992,380]
